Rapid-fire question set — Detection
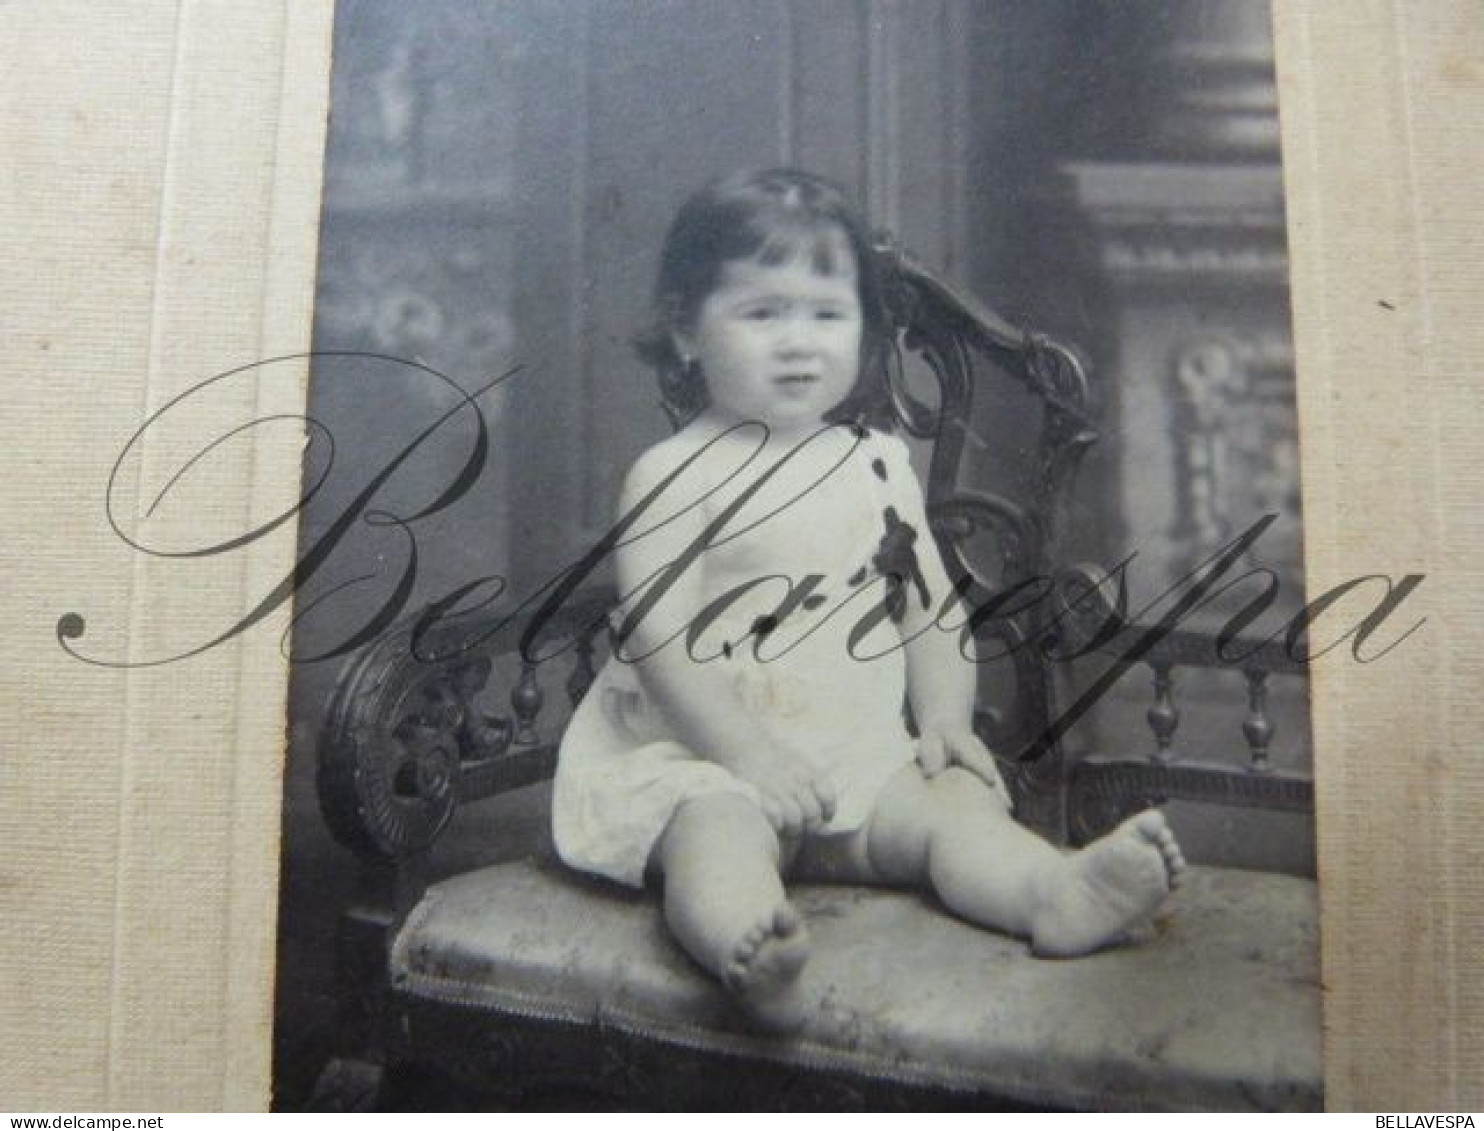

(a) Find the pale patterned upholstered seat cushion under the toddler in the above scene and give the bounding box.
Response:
[392,861,1322,1110]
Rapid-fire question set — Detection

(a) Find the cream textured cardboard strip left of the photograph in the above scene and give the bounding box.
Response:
[0,0,329,1110]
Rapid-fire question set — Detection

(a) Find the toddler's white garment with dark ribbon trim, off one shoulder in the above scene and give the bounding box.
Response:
[552,430,941,886]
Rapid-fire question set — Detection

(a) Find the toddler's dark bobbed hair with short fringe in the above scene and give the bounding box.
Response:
[634,169,889,426]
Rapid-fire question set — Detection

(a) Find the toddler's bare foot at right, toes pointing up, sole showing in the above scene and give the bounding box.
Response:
[1031,810,1186,957]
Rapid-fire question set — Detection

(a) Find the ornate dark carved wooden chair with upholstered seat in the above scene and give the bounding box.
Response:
[307,249,1322,1109]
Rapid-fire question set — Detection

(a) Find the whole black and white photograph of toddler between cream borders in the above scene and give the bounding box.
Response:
[273,0,1323,1110]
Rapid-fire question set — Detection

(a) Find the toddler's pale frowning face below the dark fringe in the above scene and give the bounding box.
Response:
[677,236,861,435]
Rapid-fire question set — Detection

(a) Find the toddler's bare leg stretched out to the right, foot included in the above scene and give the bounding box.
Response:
[868,767,1184,957]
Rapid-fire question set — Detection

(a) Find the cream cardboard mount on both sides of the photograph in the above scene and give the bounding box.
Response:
[0,0,1484,1112]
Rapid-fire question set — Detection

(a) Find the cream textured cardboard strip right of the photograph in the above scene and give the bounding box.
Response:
[1275,0,1484,1110]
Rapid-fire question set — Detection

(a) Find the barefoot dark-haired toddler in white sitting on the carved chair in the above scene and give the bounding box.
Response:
[552,171,1184,1030]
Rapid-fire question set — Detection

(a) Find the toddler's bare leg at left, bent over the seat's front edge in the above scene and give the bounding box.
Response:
[656,794,809,1030]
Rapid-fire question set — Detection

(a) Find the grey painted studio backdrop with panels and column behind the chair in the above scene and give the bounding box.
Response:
[276,0,1313,1109]
